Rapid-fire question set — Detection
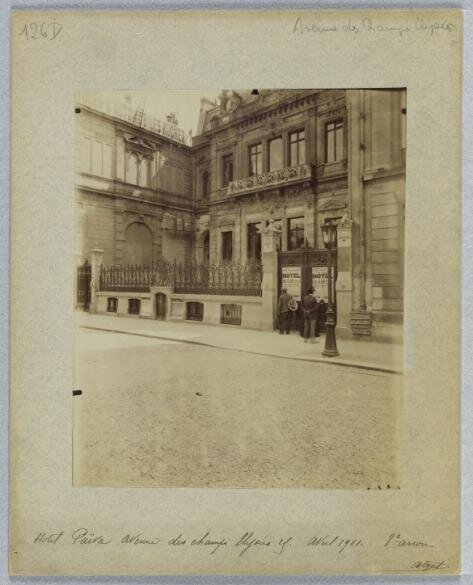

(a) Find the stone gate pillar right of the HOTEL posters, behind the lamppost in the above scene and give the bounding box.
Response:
[336,220,353,330]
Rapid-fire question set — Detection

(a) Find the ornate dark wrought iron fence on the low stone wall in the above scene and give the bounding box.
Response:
[100,261,263,296]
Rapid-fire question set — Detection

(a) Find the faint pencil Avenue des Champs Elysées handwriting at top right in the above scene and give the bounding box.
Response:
[292,16,456,37]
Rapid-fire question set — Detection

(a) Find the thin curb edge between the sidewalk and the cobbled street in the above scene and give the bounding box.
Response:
[79,325,402,376]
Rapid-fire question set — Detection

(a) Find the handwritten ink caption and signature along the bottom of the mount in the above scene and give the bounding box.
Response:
[33,528,448,571]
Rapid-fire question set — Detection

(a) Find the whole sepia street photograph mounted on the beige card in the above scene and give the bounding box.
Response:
[73,88,406,489]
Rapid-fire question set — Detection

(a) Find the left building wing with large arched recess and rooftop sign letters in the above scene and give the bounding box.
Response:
[76,100,194,265]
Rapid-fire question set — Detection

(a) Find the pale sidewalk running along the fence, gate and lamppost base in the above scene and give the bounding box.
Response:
[76,311,403,373]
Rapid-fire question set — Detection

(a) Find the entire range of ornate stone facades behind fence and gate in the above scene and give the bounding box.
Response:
[77,89,406,335]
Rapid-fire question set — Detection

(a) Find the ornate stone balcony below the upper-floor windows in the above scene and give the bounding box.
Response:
[227,164,312,197]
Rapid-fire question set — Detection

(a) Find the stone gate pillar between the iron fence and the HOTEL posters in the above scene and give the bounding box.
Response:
[261,230,279,331]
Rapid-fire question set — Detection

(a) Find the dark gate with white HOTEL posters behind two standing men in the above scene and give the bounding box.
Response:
[278,245,337,331]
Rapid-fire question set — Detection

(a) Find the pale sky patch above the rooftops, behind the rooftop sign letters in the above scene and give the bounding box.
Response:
[97,89,222,135]
